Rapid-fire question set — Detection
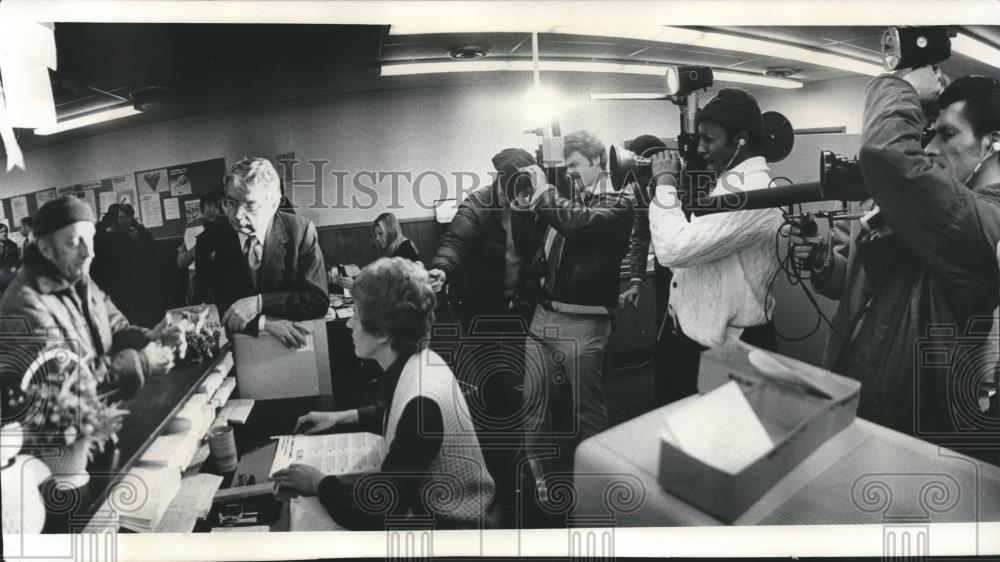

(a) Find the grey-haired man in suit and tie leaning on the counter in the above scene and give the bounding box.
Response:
[195,158,330,347]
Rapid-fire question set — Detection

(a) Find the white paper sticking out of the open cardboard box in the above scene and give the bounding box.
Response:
[664,382,774,474]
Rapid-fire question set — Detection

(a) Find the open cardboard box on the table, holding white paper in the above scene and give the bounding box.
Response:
[659,336,861,523]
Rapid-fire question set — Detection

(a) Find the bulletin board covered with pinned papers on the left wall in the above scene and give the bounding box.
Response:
[0,158,226,238]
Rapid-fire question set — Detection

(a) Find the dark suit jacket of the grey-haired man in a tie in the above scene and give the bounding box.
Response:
[195,211,330,335]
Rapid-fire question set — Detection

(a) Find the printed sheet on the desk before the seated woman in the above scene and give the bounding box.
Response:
[268,433,383,476]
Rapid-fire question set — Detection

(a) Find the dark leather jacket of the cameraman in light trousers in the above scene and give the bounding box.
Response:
[531,187,635,309]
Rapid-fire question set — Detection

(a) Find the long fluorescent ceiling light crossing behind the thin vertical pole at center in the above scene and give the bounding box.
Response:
[382,60,802,89]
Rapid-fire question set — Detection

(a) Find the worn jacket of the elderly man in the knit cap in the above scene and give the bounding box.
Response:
[0,245,149,389]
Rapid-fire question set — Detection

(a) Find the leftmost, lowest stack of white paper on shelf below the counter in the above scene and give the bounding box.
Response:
[118,467,181,532]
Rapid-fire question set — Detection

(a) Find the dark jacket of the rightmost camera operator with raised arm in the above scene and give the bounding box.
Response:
[815,76,1000,440]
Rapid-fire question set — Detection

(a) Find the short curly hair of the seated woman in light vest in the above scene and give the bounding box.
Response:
[351,258,437,353]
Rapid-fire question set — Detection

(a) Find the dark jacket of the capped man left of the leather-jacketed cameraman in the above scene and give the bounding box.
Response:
[430,182,537,328]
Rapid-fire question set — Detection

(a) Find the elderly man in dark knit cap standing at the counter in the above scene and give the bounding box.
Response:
[0,195,176,392]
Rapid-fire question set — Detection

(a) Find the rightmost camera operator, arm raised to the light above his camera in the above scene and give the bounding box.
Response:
[792,67,1000,434]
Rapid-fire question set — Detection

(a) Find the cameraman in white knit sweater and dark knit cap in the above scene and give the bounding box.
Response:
[649,88,782,399]
